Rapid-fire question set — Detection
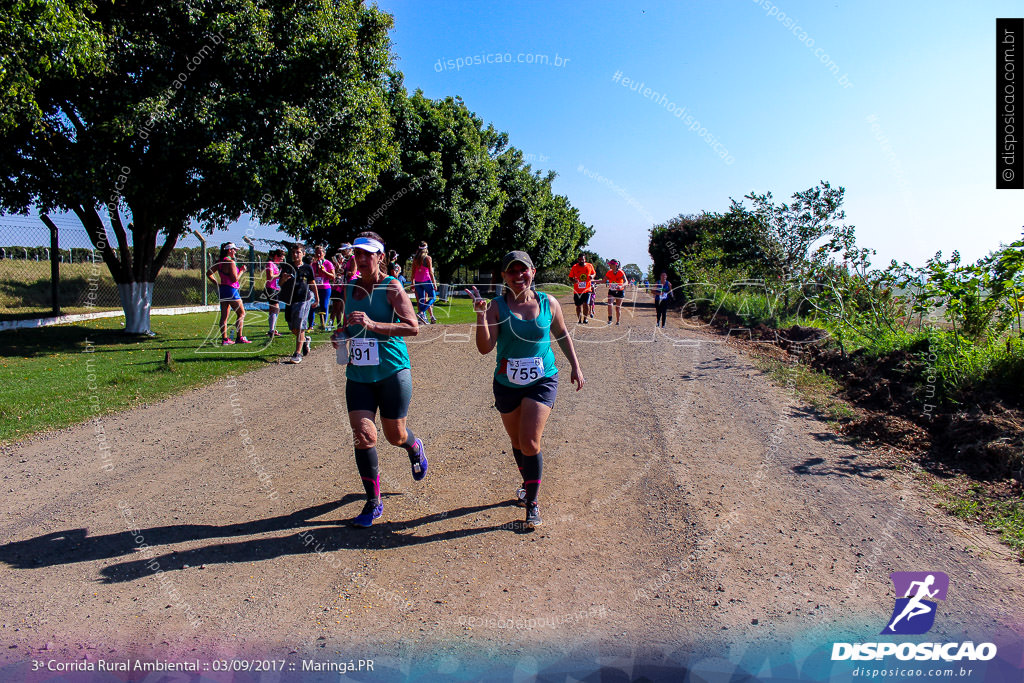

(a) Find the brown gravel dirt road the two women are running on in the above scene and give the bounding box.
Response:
[0,296,1024,672]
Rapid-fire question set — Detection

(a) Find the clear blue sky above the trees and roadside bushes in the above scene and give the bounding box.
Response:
[335,0,1024,272]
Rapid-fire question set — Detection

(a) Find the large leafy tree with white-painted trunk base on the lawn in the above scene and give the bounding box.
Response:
[0,0,395,333]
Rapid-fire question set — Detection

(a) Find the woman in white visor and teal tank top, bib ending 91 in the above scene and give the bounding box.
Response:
[331,231,427,527]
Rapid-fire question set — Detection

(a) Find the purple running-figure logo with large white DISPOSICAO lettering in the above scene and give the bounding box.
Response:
[831,571,996,661]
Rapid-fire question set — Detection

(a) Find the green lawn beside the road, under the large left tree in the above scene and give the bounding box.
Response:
[0,311,311,442]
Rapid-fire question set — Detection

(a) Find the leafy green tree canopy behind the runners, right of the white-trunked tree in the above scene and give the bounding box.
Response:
[327,79,593,281]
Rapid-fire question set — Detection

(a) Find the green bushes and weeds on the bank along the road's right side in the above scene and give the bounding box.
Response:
[649,181,1024,557]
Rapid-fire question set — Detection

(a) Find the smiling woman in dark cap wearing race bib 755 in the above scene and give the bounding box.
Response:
[466,251,586,528]
